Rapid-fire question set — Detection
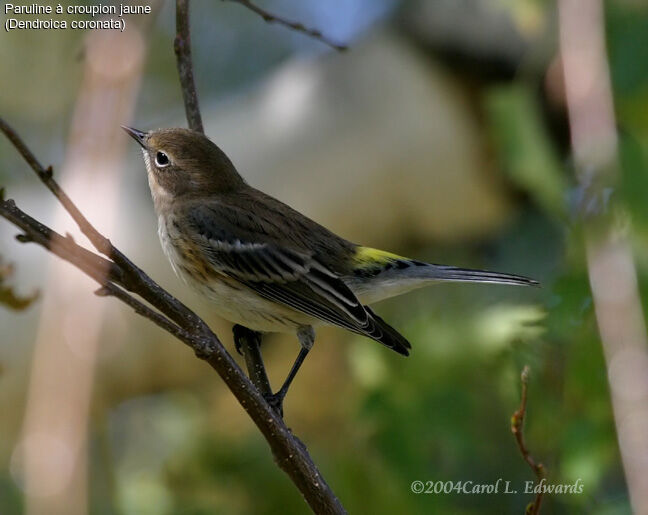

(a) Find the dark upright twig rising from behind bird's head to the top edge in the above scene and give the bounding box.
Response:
[173,0,205,132]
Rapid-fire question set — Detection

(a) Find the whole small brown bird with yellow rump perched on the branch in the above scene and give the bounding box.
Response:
[122,126,538,413]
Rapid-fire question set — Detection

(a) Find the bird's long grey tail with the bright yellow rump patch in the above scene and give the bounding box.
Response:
[347,247,539,304]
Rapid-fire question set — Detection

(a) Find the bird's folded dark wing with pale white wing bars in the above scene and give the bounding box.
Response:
[182,204,409,354]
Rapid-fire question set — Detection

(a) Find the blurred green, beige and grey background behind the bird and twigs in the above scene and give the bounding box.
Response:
[0,0,648,515]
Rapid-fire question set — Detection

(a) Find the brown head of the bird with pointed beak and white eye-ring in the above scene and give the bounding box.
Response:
[122,126,245,202]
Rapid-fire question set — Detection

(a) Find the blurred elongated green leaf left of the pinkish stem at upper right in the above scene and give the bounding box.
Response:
[486,84,566,220]
